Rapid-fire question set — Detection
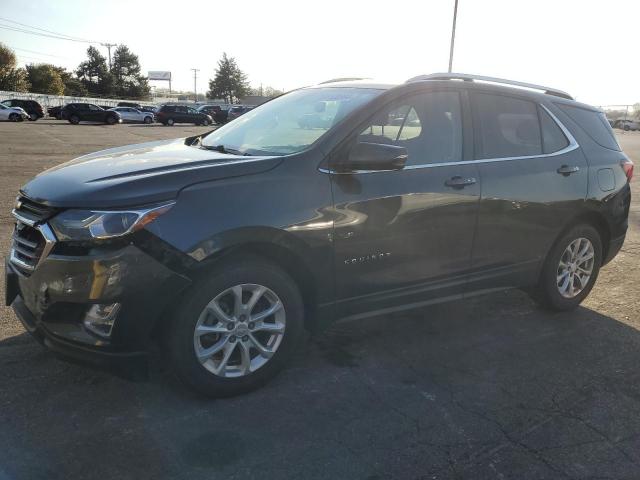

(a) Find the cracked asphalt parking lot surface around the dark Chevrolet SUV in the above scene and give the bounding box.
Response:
[0,120,640,480]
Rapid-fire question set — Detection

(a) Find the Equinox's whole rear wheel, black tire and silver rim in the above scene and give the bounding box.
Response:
[533,224,602,312]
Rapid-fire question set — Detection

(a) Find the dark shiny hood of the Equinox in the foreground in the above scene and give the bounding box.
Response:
[21,138,281,208]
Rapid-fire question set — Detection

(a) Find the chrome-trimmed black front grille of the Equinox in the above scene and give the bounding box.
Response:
[9,197,56,276]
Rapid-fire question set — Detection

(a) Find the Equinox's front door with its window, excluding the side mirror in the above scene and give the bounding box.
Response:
[332,90,480,316]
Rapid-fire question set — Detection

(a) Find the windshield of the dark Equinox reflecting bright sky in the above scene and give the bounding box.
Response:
[202,87,382,155]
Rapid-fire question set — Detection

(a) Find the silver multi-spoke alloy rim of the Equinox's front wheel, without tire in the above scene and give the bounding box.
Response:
[193,283,286,378]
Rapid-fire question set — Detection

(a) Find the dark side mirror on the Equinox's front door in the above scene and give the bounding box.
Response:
[341,142,409,172]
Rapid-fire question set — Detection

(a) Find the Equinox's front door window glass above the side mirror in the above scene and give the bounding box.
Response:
[358,92,462,165]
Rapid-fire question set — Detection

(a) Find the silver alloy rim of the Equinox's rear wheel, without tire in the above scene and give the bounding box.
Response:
[556,238,595,298]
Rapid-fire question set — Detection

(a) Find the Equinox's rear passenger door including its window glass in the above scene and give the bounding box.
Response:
[469,92,588,290]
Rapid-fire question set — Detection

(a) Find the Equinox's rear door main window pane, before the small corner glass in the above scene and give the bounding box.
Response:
[473,93,542,158]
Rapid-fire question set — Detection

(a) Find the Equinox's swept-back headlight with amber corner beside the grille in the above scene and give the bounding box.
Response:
[49,202,174,241]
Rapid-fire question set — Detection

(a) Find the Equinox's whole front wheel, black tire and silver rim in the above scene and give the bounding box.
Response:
[166,257,304,397]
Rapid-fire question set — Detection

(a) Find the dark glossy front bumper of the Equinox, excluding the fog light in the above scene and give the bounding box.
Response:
[5,244,190,377]
